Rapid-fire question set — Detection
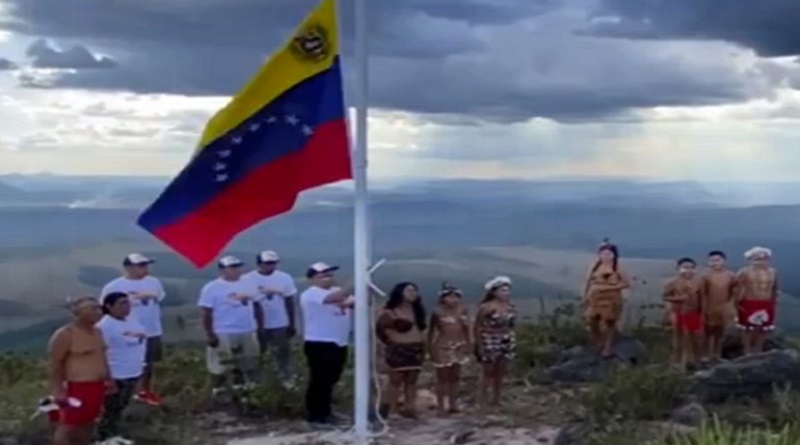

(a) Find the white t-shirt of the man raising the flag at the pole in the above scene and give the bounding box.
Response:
[300,286,353,346]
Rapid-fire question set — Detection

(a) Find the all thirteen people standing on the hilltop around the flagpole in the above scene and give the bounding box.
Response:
[42,242,779,445]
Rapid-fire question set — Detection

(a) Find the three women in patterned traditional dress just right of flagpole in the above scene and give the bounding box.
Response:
[375,276,516,418]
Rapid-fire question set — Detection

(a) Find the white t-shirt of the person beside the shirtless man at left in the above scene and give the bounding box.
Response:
[97,315,147,380]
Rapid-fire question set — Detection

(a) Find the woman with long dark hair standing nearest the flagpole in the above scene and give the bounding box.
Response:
[376,282,426,418]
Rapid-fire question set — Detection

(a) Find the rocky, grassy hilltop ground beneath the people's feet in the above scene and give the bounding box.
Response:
[0,327,800,445]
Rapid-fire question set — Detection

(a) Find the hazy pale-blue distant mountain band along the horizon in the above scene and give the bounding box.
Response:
[0,174,800,209]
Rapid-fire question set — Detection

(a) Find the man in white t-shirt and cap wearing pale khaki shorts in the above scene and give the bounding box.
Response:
[197,255,264,394]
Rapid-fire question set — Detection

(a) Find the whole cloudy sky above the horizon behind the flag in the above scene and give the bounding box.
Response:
[0,0,800,181]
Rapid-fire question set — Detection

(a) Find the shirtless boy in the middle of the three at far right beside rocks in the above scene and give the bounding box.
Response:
[703,250,736,359]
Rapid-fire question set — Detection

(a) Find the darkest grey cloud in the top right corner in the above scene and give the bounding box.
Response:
[587,0,800,56]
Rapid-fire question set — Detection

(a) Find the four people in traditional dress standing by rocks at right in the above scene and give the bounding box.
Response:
[583,240,780,368]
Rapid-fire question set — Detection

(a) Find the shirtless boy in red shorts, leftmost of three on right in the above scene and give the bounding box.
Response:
[663,258,705,367]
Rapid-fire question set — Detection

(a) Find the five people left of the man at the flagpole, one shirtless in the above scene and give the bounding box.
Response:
[47,251,302,445]
